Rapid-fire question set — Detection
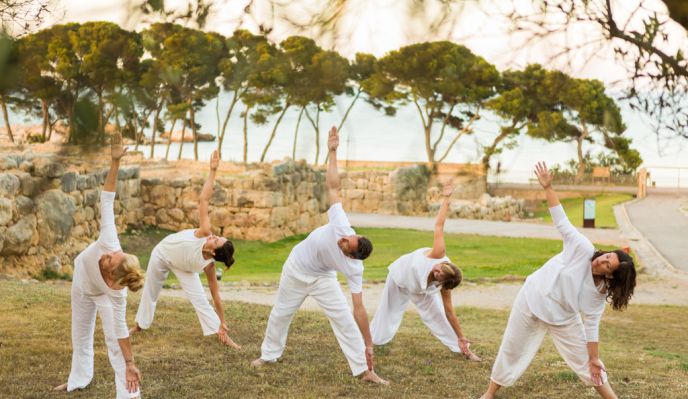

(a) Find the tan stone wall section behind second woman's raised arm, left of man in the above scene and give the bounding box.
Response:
[141,161,327,241]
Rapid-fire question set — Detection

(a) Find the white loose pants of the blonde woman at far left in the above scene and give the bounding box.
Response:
[67,284,141,399]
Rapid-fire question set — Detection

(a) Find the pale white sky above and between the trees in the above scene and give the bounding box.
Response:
[36,0,688,184]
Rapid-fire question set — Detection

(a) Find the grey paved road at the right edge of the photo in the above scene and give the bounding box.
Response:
[626,194,688,271]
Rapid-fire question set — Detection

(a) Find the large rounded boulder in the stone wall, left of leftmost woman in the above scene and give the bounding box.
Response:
[36,190,76,247]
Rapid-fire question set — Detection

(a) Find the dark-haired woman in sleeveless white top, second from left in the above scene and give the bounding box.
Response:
[131,151,240,349]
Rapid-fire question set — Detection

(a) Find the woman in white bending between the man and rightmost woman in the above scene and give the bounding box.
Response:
[370,184,480,361]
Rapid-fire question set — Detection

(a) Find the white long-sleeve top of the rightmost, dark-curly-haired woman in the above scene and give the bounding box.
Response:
[524,205,606,342]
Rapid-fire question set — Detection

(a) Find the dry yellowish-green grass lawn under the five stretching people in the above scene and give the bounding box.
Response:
[0,280,688,399]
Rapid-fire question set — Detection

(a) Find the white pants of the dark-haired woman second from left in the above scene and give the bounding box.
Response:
[136,251,220,336]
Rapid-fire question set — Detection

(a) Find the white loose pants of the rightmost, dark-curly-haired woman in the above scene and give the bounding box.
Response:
[491,288,607,386]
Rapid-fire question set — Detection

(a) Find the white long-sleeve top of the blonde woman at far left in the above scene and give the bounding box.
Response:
[72,191,129,339]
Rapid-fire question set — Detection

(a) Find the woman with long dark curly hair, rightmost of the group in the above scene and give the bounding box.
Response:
[482,162,636,399]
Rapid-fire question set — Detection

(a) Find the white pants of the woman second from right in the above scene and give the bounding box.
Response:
[370,275,461,352]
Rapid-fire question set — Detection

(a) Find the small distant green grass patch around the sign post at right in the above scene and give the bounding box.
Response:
[535,193,633,228]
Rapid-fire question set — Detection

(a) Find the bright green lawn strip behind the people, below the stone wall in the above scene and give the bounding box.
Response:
[121,228,613,284]
